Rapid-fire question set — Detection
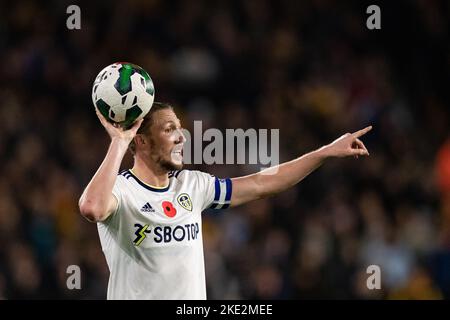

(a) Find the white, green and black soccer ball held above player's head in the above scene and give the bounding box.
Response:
[92,62,155,128]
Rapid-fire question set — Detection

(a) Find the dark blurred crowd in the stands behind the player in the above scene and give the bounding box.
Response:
[0,0,450,299]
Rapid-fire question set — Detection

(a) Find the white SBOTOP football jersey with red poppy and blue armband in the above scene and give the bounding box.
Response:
[97,170,232,300]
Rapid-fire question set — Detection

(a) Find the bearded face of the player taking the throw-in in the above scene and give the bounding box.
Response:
[143,109,186,171]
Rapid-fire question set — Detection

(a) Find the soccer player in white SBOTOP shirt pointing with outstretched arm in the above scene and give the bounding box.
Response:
[79,103,371,299]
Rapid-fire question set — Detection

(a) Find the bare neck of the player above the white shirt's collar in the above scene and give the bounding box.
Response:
[131,157,169,188]
